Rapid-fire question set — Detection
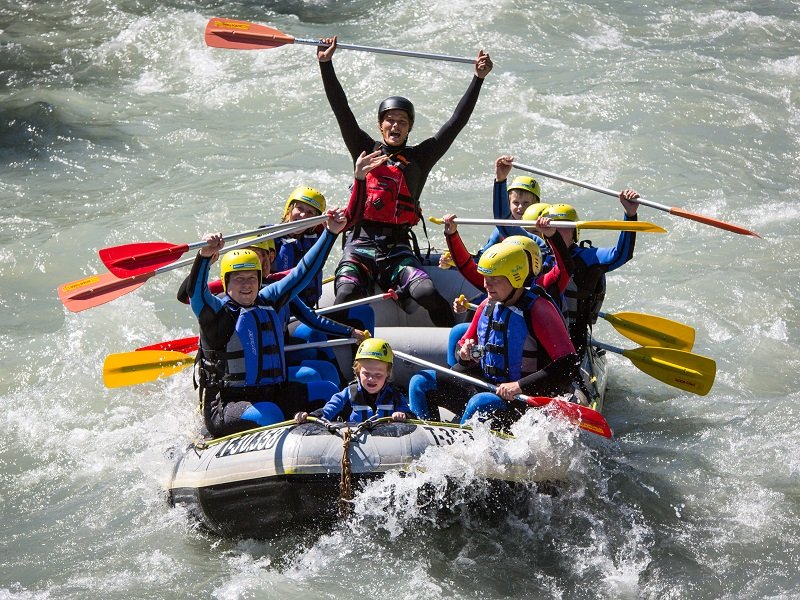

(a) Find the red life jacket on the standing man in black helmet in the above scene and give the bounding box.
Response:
[364,155,422,227]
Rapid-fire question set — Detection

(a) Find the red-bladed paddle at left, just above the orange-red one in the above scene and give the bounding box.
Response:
[98,215,327,277]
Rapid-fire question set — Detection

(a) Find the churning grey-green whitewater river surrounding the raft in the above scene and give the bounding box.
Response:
[0,0,800,600]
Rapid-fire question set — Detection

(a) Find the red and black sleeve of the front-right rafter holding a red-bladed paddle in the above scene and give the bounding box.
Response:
[518,298,580,394]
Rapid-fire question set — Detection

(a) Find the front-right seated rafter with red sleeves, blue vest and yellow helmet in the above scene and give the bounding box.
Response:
[409,243,580,424]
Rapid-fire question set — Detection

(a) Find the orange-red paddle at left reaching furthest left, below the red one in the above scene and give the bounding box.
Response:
[58,223,306,312]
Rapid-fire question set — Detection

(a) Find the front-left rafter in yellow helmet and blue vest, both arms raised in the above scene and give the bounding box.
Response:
[188,209,354,436]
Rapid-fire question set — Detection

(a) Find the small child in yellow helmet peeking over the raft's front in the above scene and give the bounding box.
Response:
[294,338,416,423]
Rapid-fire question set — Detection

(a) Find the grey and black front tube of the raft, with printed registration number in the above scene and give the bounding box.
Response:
[169,420,496,538]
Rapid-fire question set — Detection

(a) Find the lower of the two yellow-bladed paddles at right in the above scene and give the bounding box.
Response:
[591,340,717,396]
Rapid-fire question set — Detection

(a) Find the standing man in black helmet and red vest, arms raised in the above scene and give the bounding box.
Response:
[317,37,492,327]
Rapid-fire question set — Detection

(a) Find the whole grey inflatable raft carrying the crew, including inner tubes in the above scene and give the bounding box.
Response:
[168,258,606,538]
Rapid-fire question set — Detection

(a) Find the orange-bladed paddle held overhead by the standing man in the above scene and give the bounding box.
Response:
[205,17,475,64]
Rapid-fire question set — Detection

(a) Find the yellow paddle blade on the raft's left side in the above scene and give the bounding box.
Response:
[103,350,194,387]
